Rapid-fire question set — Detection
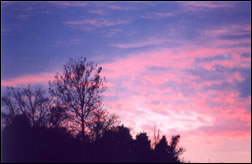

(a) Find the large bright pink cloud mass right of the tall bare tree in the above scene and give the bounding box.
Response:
[100,44,251,151]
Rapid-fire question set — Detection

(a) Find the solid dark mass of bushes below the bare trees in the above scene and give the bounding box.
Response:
[2,115,183,163]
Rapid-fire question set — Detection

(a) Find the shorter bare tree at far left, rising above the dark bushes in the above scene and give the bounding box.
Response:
[1,85,49,126]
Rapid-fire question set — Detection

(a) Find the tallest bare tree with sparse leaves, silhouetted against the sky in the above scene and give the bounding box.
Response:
[49,57,105,139]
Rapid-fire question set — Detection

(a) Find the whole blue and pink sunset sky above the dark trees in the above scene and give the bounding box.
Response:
[1,1,251,162]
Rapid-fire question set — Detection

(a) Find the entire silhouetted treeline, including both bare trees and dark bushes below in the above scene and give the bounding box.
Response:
[1,58,184,163]
